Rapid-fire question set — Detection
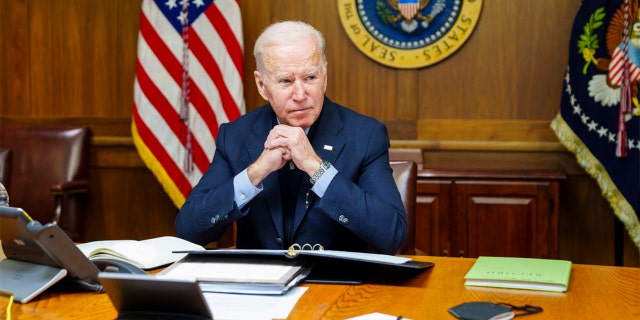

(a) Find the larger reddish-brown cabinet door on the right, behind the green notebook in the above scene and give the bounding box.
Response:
[452,180,558,258]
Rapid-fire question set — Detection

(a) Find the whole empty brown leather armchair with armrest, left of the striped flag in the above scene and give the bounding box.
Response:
[0,124,91,241]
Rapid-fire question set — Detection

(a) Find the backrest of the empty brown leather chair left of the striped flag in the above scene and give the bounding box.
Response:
[0,124,90,232]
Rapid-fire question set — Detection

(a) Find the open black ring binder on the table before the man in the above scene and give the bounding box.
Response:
[176,244,433,284]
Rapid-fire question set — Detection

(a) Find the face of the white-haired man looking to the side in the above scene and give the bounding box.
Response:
[254,37,327,128]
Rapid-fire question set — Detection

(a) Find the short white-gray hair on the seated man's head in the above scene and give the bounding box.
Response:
[253,21,327,74]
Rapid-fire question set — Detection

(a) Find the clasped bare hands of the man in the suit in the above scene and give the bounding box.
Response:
[247,124,320,186]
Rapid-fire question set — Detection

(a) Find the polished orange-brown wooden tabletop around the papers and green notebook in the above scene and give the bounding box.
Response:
[2,257,640,320]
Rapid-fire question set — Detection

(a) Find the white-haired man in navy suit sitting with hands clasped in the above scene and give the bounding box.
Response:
[175,21,407,254]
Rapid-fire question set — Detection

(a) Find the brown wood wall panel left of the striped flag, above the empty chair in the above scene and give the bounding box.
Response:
[27,0,140,117]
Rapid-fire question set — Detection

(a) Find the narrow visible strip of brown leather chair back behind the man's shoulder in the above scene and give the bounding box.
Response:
[389,160,418,254]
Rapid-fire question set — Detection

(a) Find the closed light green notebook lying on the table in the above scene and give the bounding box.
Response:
[464,256,571,292]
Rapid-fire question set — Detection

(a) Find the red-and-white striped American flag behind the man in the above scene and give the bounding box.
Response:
[131,0,245,207]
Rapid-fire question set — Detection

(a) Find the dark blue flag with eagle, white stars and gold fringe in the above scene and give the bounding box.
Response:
[551,0,640,248]
